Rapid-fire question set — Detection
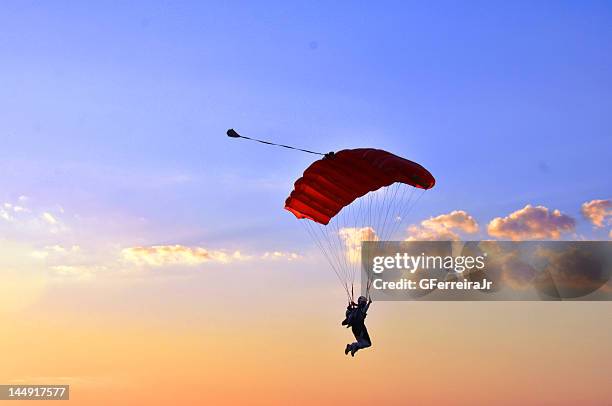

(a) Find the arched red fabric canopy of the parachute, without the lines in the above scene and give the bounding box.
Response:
[285,148,436,224]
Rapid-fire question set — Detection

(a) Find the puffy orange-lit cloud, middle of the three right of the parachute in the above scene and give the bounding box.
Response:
[487,204,576,241]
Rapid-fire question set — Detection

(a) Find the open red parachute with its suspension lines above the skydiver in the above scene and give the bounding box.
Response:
[285,148,435,301]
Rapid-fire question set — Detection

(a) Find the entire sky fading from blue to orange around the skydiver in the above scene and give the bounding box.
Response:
[0,1,612,404]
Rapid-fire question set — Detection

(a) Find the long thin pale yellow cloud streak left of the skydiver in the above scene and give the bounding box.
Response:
[121,244,301,267]
